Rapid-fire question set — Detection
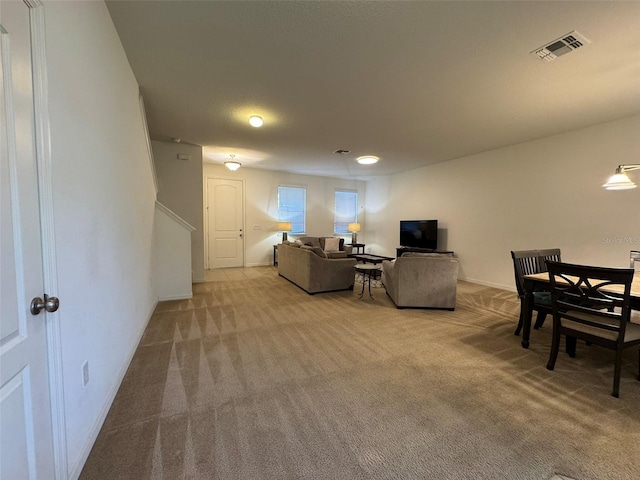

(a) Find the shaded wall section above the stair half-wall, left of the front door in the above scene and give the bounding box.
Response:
[151,140,205,282]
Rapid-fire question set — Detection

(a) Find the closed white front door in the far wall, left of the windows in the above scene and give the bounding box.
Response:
[207,178,244,268]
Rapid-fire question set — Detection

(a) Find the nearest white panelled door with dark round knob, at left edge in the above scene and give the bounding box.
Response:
[0,1,54,479]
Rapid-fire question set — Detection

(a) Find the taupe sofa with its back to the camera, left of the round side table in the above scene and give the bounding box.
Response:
[278,243,356,294]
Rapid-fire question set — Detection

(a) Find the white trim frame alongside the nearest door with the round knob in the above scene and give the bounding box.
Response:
[24,0,69,479]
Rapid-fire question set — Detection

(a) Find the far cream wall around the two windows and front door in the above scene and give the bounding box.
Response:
[204,163,367,267]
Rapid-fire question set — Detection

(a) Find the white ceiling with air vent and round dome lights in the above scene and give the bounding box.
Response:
[107,1,640,179]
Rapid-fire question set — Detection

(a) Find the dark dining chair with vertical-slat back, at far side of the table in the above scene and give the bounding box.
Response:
[511,248,560,335]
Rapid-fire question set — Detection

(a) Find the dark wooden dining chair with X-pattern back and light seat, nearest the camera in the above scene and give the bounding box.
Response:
[547,261,640,398]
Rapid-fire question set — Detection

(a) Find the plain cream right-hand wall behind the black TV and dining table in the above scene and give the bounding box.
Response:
[366,116,640,289]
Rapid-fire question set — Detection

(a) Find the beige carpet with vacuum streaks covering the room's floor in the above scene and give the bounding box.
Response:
[81,267,640,480]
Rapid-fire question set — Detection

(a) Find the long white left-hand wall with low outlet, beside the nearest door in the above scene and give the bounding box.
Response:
[45,2,157,478]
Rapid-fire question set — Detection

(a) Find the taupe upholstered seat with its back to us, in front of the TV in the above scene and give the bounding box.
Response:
[382,252,458,310]
